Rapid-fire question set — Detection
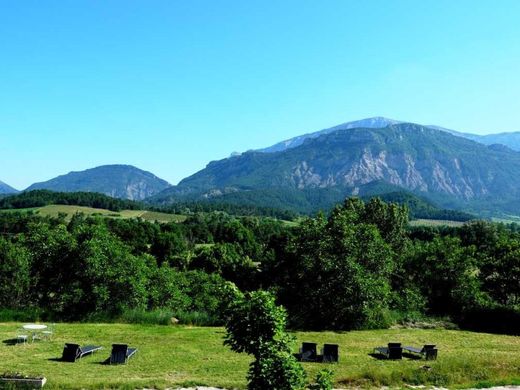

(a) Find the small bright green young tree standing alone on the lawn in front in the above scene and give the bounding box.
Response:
[224,291,305,390]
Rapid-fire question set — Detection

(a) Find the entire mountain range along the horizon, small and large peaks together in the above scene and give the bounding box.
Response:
[6,117,520,215]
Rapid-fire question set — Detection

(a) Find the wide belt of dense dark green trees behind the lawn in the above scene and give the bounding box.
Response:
[0,199,520,333]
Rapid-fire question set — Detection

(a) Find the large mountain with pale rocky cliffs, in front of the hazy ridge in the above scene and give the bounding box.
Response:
[150,123,520,215]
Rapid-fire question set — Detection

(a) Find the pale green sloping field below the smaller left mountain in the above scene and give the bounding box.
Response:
[2,205,186,223]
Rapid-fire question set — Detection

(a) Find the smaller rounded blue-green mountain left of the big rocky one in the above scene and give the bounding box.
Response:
[27,165,170,200]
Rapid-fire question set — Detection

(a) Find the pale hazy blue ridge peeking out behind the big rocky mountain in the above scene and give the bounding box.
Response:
[258,117,520,153]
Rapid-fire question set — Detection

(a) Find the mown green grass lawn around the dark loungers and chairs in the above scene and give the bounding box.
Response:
[0,323,520,389]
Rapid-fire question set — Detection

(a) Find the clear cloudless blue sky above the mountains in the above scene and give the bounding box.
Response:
[0,0,520,189]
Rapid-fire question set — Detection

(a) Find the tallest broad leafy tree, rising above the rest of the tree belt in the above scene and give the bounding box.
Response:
[280,199,395,329]
